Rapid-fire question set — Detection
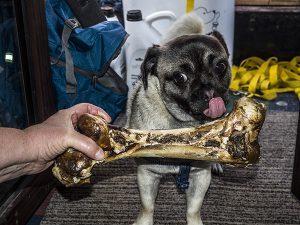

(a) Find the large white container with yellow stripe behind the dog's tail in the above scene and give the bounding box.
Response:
[123,0,235,62]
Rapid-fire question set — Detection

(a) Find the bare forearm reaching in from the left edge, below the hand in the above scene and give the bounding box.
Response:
[0,125,52,183]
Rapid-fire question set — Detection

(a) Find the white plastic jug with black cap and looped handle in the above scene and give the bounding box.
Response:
[124,10,176,90]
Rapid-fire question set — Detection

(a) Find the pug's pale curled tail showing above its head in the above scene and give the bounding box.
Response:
[161,13,204,44]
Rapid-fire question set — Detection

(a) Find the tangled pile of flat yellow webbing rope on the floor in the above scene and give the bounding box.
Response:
[230,56,300,100]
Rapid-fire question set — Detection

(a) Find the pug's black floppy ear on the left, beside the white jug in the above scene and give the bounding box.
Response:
[141,45,161,90]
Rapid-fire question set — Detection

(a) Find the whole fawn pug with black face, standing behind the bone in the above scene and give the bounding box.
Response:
[126,14,231,225]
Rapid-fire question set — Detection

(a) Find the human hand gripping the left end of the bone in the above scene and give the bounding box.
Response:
[25,103,111,174]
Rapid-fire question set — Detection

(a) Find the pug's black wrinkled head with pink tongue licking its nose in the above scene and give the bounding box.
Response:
[142,32,231,121]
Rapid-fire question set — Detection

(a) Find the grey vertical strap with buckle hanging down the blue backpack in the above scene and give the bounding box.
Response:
[61,18,80,94]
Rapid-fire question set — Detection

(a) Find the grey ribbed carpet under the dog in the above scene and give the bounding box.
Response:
[42,111,300,225]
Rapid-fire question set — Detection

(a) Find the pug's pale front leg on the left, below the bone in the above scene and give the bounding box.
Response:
[133,165,162,225]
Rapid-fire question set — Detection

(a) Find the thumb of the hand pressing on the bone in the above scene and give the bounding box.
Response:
[67,131,104,160]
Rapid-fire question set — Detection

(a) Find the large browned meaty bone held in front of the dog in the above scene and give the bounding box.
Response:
[52,97,266,186]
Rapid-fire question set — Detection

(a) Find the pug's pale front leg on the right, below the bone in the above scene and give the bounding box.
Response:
[186,166,211,225]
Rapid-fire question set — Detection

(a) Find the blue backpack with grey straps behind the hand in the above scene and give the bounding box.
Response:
[46,0,128,119]
